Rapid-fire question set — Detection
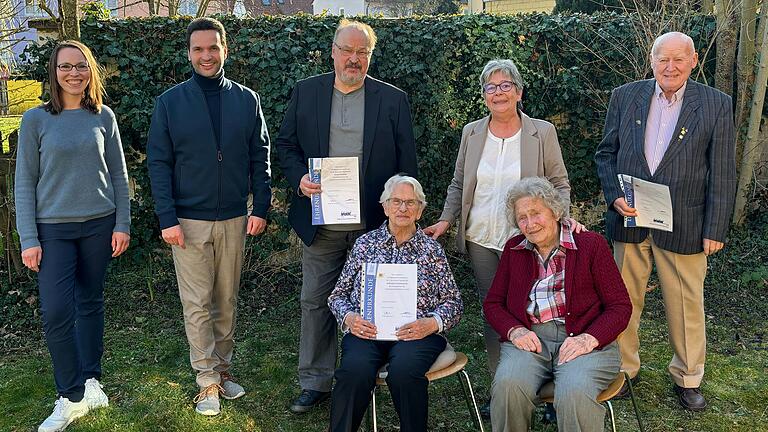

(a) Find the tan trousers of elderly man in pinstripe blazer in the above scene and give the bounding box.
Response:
[614,235,707,388]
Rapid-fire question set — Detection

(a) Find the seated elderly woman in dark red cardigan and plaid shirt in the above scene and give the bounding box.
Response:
[483,177,632,432]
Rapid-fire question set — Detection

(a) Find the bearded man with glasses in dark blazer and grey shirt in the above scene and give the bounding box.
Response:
[275,20,417,413]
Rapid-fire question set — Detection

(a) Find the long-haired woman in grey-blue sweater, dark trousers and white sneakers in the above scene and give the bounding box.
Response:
[16,41,130,432]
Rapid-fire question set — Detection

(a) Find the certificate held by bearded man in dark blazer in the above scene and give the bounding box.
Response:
[309,157,360,225]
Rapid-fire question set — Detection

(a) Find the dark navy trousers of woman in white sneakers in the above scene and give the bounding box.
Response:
[37,214,115,402]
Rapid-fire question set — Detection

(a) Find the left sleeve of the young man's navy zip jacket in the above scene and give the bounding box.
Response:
[147,98,179,229]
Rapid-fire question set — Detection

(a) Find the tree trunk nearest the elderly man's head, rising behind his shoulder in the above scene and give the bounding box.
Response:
[715,0,738,96]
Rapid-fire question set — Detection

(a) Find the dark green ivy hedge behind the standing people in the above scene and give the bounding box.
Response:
[18,14,715,262]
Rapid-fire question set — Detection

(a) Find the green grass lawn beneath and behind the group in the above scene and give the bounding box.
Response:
[0,224,768,432]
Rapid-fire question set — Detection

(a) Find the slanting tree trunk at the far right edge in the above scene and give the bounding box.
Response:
[733,4,768,224]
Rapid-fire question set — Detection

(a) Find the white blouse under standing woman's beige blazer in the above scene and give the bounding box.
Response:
[465,128,520,251]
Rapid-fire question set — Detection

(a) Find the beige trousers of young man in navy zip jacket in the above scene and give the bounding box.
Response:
[172,216,247,387]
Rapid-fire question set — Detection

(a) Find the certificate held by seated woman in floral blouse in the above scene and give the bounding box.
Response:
[360,263,417,340]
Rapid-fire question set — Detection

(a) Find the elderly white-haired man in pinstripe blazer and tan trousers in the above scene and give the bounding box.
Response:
[595,32,736,411]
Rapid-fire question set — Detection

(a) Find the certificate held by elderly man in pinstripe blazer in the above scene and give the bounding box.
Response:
[619,174,672,232]
